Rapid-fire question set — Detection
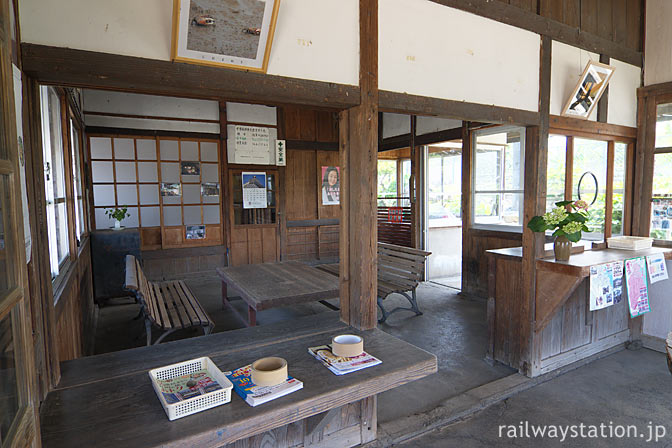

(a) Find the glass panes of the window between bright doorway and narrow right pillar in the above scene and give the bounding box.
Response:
[472,128,525,227]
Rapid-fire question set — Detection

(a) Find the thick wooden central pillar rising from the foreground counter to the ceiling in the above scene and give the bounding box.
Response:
[339,0,378,329]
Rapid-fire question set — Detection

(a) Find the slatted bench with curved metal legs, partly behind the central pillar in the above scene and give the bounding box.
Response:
[316,243,432,323]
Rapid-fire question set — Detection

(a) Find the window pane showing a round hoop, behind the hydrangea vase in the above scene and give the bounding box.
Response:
[572,138,609,240]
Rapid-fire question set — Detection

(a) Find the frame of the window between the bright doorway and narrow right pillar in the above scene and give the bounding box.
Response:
[469,126,527,233]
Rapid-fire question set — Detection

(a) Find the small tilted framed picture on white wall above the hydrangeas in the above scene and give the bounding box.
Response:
[562,61,614,119]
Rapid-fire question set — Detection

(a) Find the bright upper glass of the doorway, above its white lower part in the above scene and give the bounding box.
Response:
[427,150,462,227]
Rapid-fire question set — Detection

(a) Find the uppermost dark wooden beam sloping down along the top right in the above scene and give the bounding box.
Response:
[430,0,643,67]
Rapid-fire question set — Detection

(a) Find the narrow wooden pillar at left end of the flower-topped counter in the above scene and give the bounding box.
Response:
[512,36,551,375]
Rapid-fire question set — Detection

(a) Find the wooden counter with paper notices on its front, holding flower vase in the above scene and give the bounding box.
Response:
[487,245,672,376]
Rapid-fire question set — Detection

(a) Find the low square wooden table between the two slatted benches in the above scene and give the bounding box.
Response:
[217,261,339,327]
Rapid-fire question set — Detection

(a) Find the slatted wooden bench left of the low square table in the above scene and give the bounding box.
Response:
[124,255,215,345]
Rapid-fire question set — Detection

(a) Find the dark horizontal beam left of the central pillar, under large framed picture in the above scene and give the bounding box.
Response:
[21,43,360,109]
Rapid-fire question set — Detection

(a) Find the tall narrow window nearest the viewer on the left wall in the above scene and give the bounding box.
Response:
[40,86,69,277]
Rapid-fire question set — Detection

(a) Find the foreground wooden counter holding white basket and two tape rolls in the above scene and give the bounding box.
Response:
[41,312,437,448]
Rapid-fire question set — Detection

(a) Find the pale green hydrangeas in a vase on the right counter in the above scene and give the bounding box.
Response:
[527,200,590,261]
